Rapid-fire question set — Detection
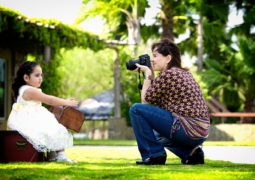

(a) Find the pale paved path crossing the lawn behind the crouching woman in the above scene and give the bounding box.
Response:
[75,146,255,164]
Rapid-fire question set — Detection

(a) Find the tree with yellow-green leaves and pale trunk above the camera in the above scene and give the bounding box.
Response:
[76,0,147,55]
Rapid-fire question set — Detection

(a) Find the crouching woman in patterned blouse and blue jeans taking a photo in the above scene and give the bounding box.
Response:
[130,39,210,165]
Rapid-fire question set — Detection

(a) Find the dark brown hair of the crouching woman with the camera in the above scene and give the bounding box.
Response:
[151,39,184,69]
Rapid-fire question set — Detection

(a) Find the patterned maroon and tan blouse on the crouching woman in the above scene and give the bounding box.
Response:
[145,68,210,138]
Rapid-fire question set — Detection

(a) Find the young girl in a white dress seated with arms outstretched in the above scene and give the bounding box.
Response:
[8,61,78,163]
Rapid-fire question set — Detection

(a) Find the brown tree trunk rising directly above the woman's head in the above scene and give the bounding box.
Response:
[160,0,174,41]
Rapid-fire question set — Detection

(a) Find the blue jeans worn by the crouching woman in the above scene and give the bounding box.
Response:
[130,103,206,160]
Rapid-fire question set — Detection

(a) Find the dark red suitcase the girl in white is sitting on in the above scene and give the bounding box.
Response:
[0,131,46,163]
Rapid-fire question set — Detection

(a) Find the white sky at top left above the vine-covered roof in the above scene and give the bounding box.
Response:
[0,0,103,34]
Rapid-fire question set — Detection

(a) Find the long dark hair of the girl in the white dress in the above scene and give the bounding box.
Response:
[12,61,38,99]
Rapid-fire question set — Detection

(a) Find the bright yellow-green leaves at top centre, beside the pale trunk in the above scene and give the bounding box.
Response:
[76,0,148,39]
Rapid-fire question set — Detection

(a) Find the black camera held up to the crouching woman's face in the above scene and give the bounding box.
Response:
[126,54,151,71]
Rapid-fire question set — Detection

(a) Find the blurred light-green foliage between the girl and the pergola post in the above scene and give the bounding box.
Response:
[56,48,114,100]
